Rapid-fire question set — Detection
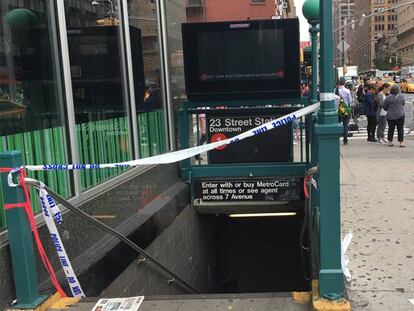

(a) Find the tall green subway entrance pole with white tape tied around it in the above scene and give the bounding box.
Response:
[316,0,345,298]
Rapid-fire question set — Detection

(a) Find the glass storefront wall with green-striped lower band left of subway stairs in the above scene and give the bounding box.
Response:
[0,0,196,232]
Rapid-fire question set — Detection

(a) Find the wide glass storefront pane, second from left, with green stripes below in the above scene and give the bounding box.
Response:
[64,0,132,190]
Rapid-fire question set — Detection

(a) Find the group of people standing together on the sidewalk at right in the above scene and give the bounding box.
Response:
[335,78,405,147]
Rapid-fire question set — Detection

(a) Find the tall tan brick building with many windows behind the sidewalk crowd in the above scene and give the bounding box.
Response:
[351,0,398,72]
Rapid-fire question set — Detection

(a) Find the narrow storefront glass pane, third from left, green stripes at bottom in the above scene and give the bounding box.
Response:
[128,0,166,158]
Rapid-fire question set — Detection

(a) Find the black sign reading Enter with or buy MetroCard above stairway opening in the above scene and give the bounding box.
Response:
[194,177,303,204]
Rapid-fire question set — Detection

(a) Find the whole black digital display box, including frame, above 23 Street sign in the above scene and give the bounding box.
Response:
[182,19,300,100]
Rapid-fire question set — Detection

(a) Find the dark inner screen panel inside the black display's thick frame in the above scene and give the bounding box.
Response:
[198,29,285,81]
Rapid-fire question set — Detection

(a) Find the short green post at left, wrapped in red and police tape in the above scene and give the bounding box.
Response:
[0,151,47,309]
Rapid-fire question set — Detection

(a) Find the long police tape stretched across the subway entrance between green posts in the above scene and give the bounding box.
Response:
[24,103,320,171]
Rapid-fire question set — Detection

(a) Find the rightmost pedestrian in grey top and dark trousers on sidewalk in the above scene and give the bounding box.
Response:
[384,85,405,147]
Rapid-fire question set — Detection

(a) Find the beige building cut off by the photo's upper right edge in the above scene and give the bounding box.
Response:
[397,0,414,66]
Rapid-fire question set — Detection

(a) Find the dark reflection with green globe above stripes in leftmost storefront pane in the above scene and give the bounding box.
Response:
[0,1,64,136]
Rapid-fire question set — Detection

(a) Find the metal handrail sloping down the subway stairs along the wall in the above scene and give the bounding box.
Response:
[24,178,200,294]
